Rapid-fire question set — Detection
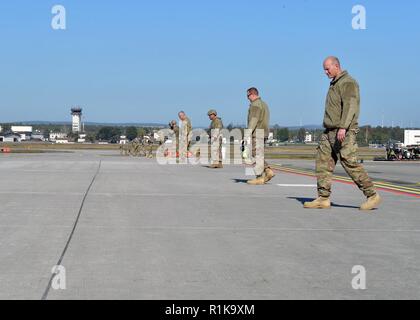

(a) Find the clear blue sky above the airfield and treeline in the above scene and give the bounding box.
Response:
[0,0,420,126]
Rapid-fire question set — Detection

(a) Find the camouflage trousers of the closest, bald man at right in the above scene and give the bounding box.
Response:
[316,130,376,198]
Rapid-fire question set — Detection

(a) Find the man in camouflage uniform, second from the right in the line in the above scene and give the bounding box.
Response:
[245,88,274,185]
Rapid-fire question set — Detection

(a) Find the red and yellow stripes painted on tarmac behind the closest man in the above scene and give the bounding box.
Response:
[272,165,420,198]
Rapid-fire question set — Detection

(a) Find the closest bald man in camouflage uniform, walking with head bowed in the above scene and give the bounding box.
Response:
[304,57,381,210]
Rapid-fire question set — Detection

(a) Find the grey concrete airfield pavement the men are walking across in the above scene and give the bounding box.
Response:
[0,151,420,300]
